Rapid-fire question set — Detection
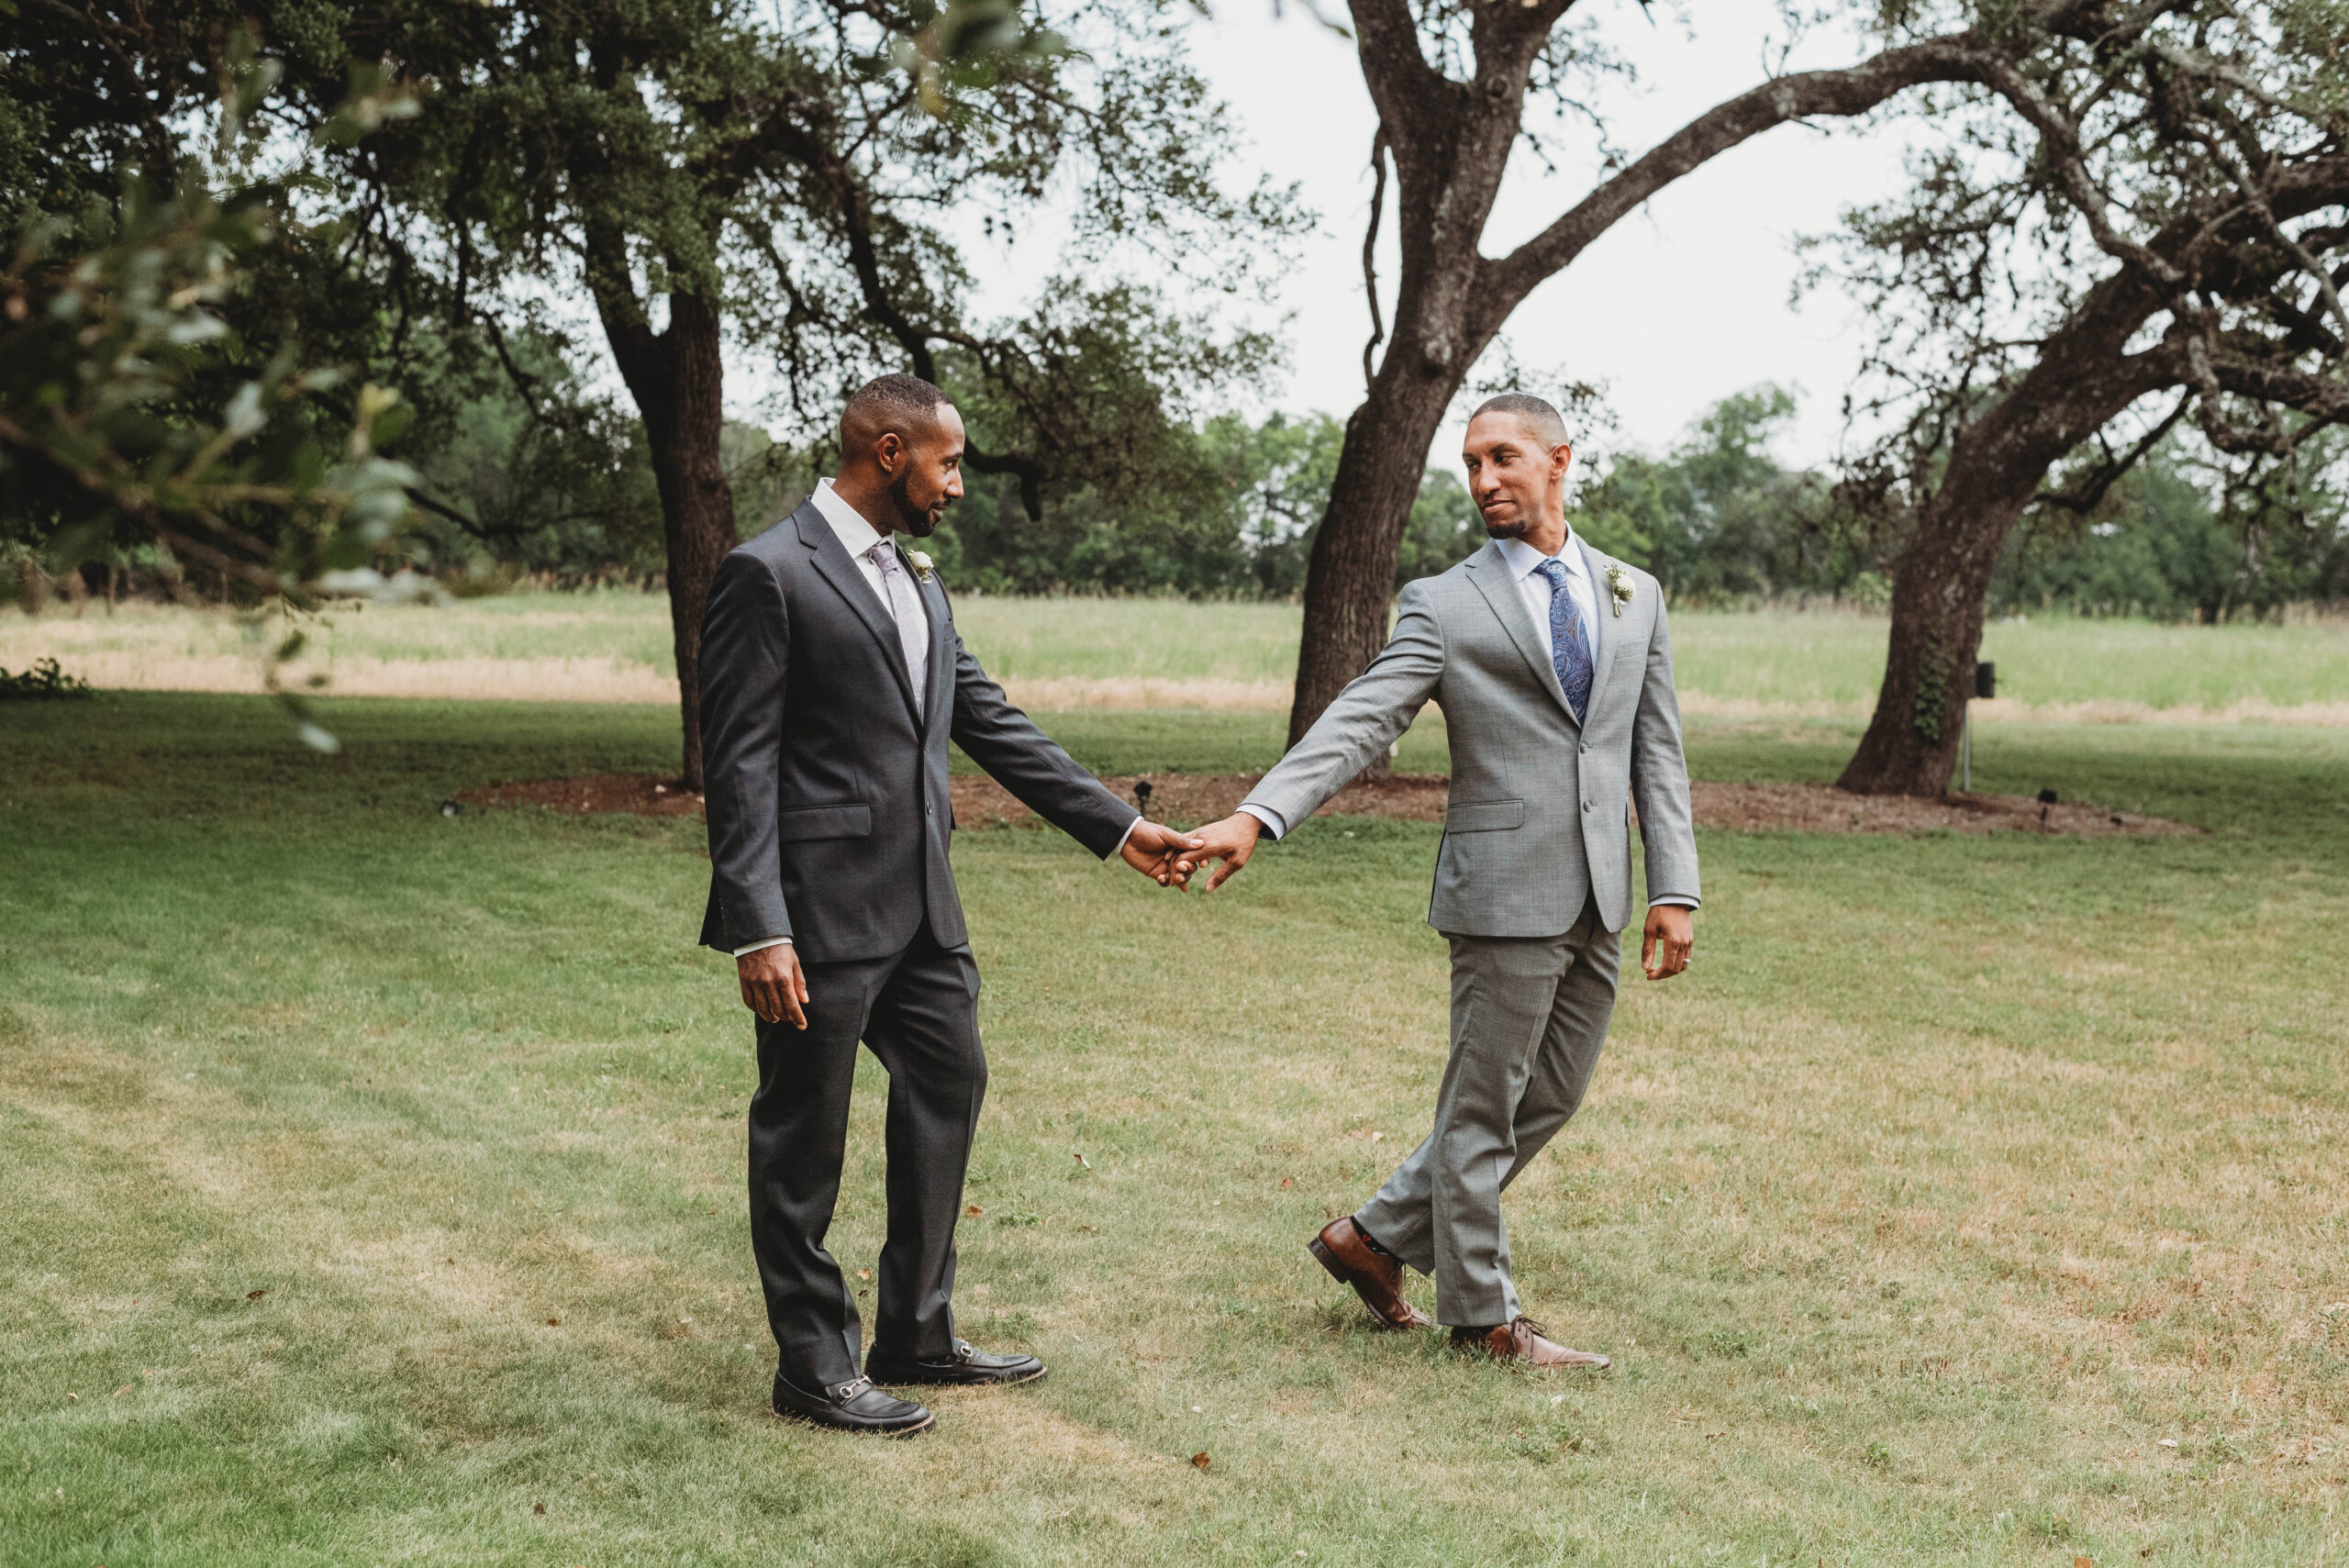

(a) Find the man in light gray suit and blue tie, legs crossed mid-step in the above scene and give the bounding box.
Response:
[1184,395,1698,1366]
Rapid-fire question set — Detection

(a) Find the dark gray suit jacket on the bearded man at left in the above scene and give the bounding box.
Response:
[702,502,1140,962]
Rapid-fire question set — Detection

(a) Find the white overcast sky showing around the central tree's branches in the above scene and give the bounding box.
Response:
[944,0,1935,478]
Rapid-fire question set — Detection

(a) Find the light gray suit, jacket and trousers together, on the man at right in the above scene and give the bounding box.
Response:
[1247,545,1698,1329]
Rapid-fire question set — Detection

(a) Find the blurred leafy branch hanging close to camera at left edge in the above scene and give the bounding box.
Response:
[0,36,423,749]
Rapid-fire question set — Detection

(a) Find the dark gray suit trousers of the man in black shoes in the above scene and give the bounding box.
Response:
[750,922,986,1387]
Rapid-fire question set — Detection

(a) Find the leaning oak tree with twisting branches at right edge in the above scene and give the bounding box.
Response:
[1837,0,2349,795]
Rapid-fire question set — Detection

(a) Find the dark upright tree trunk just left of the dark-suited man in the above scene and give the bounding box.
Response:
[604,282,735,791]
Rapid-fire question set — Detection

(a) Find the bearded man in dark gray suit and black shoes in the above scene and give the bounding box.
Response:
[702,375,1196,1437]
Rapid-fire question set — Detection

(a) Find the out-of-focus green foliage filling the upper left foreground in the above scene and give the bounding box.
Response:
[0,26,432,747]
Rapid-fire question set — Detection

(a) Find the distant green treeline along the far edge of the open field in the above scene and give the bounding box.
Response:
[14,383,2349,622]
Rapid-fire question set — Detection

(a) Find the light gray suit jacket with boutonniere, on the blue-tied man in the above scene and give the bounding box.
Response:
[1247,539,1698,937]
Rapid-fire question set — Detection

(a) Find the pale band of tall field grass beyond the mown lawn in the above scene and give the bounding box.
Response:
[18,592,2349,709]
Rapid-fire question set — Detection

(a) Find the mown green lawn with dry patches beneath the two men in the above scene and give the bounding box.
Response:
[0,695,2349,1568]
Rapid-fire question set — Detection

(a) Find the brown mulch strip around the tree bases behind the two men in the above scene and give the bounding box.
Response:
[456,773,2201,838]
